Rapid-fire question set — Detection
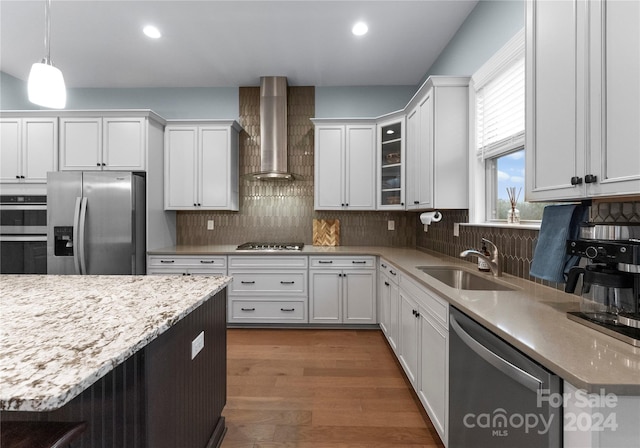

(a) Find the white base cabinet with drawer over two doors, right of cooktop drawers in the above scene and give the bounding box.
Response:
[309,257,376,324]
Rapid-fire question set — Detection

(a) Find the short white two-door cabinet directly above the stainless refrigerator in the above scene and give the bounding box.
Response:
[60,116,147,171]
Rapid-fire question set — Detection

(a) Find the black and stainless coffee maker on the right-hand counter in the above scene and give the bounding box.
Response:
[565,223,640,347]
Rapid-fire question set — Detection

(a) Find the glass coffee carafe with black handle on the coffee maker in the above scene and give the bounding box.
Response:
[565,264,636,325]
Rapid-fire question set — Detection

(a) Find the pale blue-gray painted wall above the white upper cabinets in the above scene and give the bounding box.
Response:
[0,0,524,119]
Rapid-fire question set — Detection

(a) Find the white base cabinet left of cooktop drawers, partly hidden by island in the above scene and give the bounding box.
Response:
[147,255,227,275]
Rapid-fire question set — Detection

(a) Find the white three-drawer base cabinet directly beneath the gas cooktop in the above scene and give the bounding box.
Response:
[228,255,309,324]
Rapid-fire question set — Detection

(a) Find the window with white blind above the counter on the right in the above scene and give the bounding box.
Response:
[471,31,546,222]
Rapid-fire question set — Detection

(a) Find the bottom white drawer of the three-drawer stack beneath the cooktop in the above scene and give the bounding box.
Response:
[229,300,307,322]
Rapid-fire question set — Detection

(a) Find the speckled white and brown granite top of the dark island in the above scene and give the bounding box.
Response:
[0,275,231,411]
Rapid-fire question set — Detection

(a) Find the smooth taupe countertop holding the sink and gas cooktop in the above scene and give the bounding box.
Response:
[149,245,640,396]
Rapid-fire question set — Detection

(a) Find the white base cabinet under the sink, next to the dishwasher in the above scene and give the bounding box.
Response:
[397,274,449,445]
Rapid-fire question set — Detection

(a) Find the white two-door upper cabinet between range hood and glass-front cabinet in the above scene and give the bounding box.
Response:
[314,119,376,210]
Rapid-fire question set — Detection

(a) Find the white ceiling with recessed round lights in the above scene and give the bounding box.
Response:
[0,0,478,88]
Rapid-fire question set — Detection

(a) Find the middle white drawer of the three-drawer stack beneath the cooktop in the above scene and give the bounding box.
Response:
[229,271,307,296]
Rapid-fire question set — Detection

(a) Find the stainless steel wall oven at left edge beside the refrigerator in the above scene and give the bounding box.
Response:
[0,195,47,274]
